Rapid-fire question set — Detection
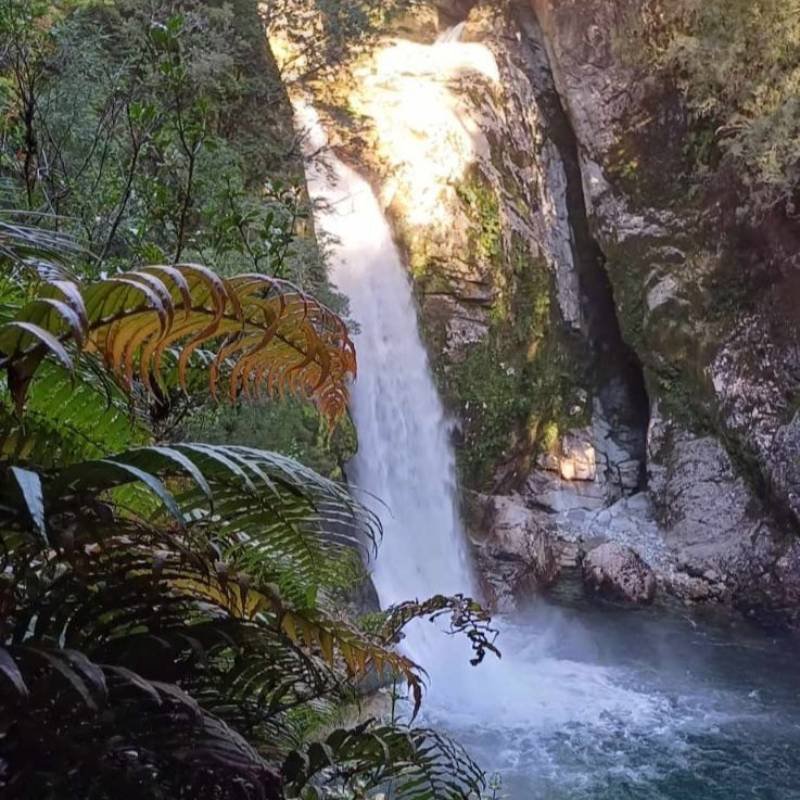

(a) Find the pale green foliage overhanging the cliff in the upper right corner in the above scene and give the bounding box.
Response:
[636,0,800,213]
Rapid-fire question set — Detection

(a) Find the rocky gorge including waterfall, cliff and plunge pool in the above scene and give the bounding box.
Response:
[296,0,800,800]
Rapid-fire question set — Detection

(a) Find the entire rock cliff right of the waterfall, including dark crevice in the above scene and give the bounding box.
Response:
[306,0,800,624]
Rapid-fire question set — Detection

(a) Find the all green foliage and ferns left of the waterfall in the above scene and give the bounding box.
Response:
[0,0,494,800]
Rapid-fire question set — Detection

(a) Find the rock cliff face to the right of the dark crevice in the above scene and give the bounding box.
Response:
[532,0,800,623]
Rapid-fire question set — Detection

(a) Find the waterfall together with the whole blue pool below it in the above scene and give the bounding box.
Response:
[298,104,800,800]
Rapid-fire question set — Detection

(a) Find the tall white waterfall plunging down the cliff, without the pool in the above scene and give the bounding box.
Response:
[297,103,472,666]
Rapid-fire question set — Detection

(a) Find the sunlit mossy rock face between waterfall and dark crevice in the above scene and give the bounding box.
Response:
[304,4,593,491]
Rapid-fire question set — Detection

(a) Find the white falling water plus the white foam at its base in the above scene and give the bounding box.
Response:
[297,103,652,724]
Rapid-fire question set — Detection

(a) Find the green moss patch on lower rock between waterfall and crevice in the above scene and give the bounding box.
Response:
[442,234,590,490]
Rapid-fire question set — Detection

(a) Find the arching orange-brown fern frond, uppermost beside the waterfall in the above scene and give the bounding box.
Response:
[0,264,356,423]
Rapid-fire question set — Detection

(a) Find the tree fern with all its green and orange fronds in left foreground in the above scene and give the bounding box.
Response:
[0,245,497,800]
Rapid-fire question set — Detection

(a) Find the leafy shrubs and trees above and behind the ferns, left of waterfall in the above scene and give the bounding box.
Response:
[0,0,352,462]
